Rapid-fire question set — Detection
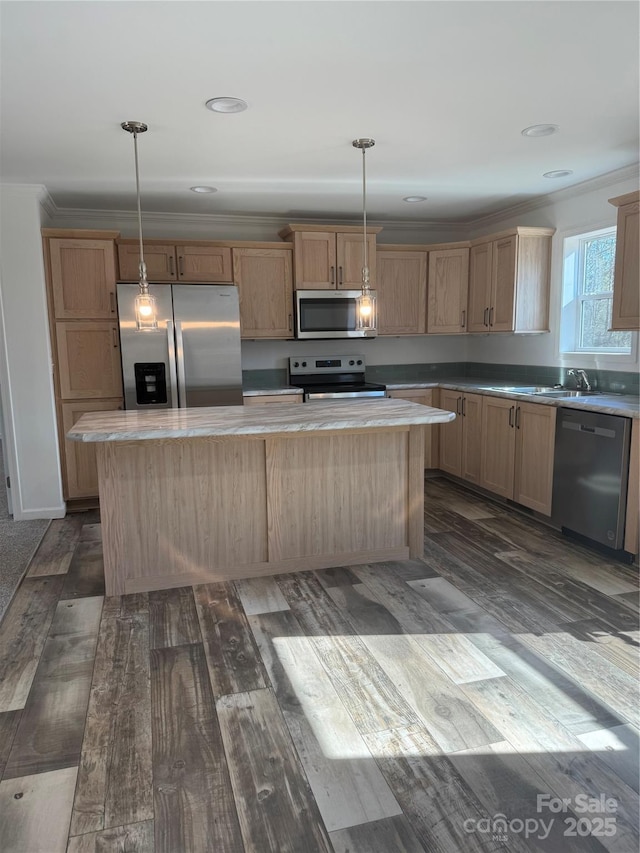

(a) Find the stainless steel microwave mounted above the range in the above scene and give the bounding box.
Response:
[295,290,377,339]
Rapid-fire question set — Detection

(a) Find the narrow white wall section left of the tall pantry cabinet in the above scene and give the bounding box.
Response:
[0,185,65,520]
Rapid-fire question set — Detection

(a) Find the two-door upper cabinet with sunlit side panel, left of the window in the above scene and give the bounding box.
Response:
[467,227,554,332]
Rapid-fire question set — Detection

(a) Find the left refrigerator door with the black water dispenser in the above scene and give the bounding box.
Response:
[117,284,178,409]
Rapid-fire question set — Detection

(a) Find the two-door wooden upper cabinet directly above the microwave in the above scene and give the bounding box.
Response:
[278,225,382,290]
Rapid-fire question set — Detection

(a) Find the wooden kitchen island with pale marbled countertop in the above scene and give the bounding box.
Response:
[67,399,455,595]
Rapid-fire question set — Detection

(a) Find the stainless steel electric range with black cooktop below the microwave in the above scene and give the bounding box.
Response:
[289,355,387,403]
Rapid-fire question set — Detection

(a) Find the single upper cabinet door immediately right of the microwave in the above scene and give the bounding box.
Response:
[376,250,427,335]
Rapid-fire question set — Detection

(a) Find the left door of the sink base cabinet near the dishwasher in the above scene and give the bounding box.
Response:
[480,396,516,498]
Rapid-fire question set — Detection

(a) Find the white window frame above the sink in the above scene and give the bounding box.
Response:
[558,222,638,366]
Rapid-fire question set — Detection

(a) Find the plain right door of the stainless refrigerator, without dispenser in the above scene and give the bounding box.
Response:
[172,284,242,408]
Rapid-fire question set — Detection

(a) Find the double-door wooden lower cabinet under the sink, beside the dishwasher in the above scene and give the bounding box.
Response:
[479,396,556,515]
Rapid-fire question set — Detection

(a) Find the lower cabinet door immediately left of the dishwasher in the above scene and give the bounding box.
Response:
[513,403,556,515]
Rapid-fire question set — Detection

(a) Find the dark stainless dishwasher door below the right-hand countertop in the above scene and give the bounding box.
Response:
[553,408,631,549]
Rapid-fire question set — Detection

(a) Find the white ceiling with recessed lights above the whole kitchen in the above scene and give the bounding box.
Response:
[0,0,640,222]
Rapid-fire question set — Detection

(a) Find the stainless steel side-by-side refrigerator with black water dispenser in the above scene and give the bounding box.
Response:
[117,283,242,409]
